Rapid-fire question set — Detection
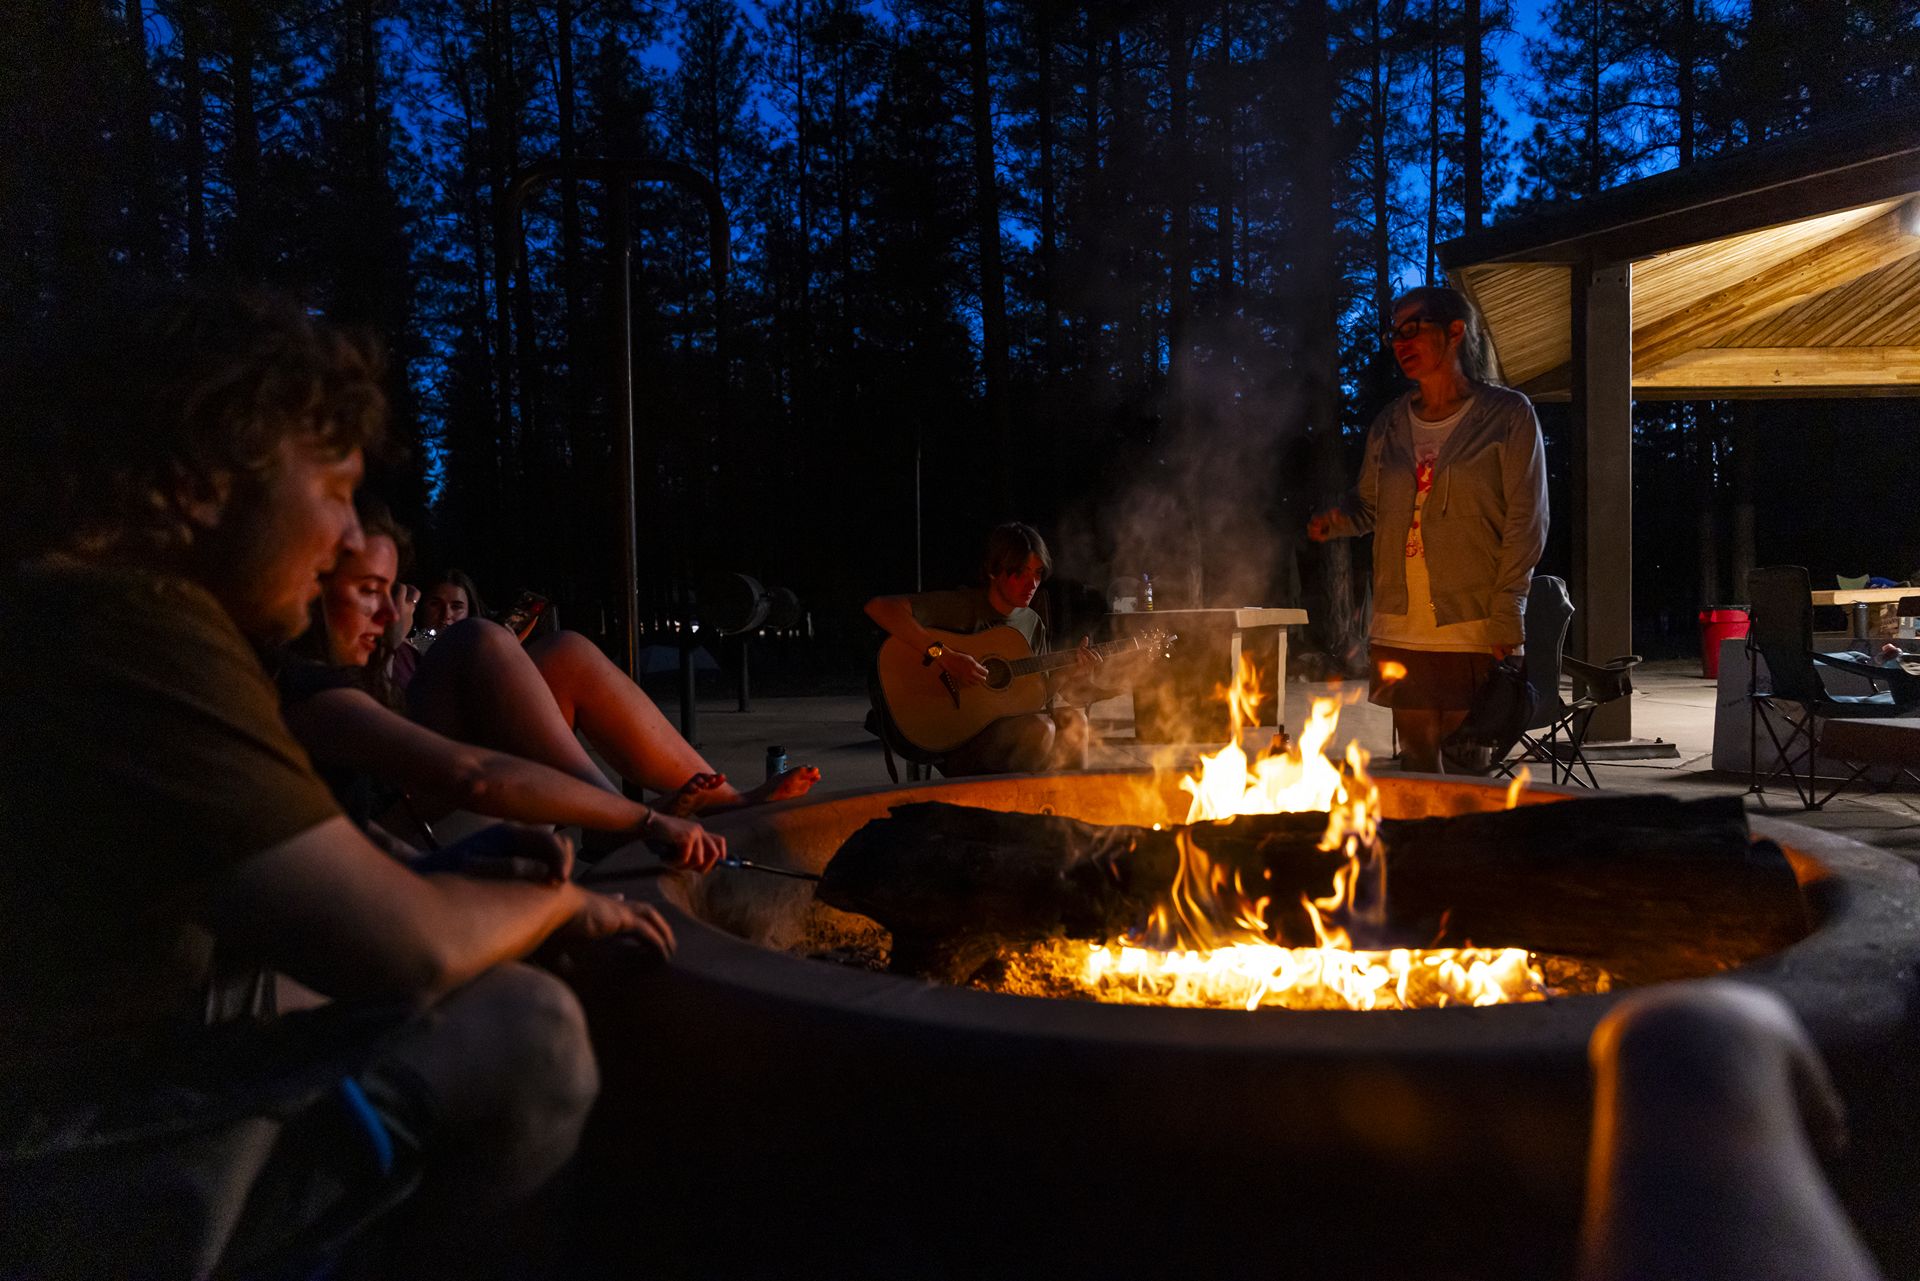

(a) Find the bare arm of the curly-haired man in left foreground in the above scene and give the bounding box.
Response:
[205,818,672,999]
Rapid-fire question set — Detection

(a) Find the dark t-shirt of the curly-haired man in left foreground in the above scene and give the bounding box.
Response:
[0,563,340,1091]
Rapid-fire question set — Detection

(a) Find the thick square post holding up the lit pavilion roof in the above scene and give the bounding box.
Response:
[1572,263,1634,741]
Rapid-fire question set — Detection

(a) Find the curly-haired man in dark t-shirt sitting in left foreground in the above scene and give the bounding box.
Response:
[0,282,674,1277]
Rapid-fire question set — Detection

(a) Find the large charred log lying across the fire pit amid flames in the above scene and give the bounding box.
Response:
[818,797,1807,983]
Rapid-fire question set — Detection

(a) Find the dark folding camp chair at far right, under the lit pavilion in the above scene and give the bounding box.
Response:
[1747,565,1920,810]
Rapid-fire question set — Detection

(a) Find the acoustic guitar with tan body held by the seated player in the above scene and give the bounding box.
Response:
[874,626,1175,755]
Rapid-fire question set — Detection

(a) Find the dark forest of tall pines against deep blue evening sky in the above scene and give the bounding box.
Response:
[11,0,1920,672]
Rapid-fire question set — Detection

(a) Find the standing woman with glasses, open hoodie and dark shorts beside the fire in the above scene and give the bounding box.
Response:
[1308,286,1548,772]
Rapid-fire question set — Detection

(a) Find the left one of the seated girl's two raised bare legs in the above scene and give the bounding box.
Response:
[407,618,618,791]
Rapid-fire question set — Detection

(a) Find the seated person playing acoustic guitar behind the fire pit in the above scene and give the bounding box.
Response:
[866,520,1106,778]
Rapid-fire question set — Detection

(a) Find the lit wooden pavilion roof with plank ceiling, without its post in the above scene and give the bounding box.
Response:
[1440,111,1920,399]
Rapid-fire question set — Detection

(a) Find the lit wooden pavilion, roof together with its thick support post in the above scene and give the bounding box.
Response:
[1440,111,1920,739]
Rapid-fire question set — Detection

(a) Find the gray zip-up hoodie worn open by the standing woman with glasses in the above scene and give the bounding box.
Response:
[1332,382,1548,645]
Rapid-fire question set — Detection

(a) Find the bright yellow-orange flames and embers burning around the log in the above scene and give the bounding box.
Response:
[1090,665,1548,1010]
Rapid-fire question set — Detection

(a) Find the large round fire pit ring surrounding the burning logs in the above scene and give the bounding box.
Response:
[586,774,1920,1279]
